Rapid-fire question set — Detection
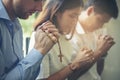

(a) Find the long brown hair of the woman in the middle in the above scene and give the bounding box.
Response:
[34,0,83,30]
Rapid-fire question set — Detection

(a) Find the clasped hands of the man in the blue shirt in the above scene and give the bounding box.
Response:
[34,21,60,55]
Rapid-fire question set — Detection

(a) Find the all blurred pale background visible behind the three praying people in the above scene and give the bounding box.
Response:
[20,0,120,80]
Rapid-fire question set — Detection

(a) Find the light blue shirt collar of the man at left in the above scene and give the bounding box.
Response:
[0,0,11,20]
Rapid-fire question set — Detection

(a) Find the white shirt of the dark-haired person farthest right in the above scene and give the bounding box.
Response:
[70,22,106,80]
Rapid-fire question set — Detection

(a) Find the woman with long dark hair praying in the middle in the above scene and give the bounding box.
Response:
[29,0,94,80]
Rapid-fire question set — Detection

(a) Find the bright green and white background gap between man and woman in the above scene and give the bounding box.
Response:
[19,14,36,56]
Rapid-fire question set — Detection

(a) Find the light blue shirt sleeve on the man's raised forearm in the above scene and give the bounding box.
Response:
[5,48,43,80]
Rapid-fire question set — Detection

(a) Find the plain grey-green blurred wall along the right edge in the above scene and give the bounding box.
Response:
[102,0,120,80]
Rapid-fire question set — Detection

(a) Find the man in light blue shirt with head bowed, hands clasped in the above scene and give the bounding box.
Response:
[0,0,59,80]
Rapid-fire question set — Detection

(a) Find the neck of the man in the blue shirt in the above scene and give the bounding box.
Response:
[3,0,16,20]
